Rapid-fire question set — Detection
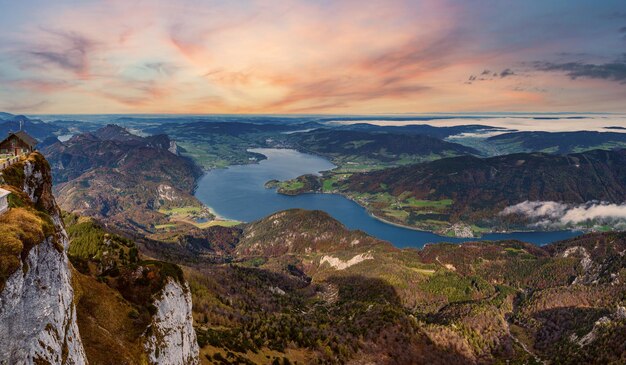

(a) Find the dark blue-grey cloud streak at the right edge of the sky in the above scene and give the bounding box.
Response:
[534,60,626,83]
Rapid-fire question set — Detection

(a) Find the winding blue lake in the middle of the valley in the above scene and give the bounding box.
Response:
[196,148,580,247]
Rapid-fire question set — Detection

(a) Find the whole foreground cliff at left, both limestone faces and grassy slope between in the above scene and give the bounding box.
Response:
[0,153,198,364]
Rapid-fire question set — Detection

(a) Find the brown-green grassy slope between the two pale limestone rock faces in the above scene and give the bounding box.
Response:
[64,214,190,365]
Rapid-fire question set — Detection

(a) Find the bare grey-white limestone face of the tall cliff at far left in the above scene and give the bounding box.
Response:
[0,156,87,364]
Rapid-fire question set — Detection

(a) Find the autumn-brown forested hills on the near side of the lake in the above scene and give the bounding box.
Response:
[140,209,626,364]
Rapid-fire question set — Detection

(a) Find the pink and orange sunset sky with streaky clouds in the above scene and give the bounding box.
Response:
[0,0,626,114]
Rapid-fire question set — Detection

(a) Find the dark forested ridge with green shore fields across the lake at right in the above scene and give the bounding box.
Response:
[276,146,626,232]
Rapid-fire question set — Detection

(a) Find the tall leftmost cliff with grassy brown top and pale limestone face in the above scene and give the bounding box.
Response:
[0,154,87,364]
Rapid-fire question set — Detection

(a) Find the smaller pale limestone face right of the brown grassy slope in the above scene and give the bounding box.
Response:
[144,279,199,365]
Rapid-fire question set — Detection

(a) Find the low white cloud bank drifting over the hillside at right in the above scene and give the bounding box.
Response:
[500,201,626,226]
